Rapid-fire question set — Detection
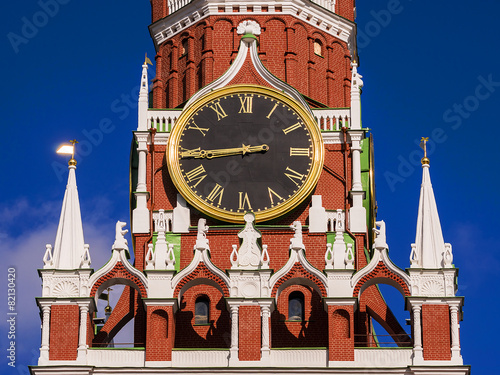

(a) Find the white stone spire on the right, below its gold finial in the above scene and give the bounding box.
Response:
[410,163,445,269]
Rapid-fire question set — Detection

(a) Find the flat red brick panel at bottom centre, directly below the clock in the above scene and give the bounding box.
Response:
[238,306,261,361]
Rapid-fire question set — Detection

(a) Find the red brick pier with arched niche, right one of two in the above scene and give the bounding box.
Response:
[328,306,354,361]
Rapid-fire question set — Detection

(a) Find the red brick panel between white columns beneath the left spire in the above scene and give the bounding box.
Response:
[49,305,80,361]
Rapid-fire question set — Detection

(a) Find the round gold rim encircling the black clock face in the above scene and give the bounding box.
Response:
[165,85,325,224]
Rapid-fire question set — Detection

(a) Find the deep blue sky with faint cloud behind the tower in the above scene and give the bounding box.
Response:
[0,0,500,374]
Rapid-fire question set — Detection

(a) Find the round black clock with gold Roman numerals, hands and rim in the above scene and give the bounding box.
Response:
[167,86,324,223]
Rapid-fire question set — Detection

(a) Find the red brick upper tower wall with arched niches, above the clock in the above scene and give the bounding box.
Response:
[153,13,351,108]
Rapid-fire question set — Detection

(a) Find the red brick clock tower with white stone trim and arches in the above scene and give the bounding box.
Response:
[32,0,470,374]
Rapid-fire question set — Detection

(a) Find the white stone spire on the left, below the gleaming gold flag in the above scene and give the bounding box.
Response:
[51,163,89,269]
